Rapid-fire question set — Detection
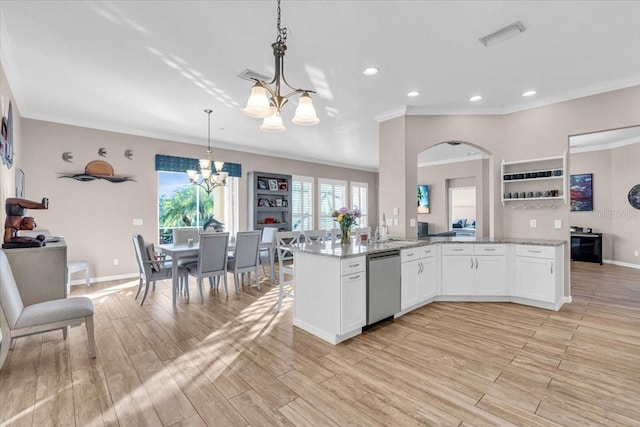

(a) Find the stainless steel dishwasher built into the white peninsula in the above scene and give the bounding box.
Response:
[367,250,400,325]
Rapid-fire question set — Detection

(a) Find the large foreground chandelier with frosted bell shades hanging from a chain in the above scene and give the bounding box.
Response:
[242,0,320,132]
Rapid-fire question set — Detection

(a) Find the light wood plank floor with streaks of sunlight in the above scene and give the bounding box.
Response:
[0,263,640,426]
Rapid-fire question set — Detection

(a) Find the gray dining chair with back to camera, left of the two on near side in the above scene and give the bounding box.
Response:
[185,233,229,302]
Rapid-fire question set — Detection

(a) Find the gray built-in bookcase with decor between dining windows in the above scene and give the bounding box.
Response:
[248,172,291,231]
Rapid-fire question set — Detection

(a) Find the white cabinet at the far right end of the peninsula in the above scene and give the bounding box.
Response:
[513,245,564,310]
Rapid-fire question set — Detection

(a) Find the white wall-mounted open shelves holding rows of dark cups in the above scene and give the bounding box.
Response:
[500,151,567,208]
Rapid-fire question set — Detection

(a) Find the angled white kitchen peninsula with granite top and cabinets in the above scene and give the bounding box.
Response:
[293,237,570,344]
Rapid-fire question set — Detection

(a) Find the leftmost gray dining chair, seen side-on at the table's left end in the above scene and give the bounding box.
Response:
[131,234,188,305]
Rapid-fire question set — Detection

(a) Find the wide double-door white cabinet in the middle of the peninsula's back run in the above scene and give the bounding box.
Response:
[442,244,508,300]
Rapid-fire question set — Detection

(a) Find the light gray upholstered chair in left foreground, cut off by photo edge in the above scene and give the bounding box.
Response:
[0,251,96,369]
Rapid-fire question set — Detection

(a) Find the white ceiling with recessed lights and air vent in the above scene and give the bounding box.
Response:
[0,0,640,170]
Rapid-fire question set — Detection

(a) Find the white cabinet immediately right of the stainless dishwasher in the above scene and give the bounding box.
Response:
[400,246,439,311]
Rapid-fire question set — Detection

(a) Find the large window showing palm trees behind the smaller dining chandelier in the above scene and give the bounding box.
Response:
[158,171,238,243]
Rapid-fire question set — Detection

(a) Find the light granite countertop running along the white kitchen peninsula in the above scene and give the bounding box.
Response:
[293,236,565,258]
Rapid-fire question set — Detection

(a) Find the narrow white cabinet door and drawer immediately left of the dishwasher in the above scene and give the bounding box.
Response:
[340,257,367,334]
